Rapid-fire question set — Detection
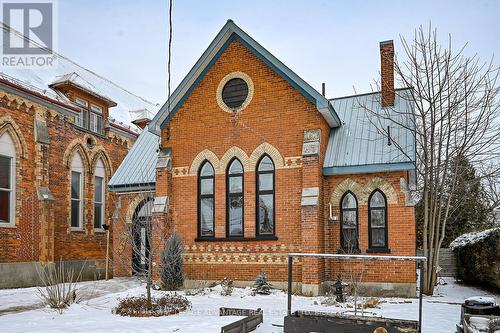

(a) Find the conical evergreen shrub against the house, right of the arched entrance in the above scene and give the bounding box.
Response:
[160,232,184,290]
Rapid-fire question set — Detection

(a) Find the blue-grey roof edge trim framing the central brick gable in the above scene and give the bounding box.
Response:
[149,20,340,135]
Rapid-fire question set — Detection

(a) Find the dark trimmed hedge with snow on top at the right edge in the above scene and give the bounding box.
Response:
[452,228,500,290]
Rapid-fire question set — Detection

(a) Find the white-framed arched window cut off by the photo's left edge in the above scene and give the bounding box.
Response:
[0,132,16,227]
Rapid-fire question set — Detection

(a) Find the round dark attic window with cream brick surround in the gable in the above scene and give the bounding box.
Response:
[217,72,253,112]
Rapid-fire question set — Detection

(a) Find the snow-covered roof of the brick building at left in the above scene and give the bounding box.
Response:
[0,23,158,130]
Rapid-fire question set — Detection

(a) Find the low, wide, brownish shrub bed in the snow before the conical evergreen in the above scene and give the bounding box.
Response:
[113,294,191,317]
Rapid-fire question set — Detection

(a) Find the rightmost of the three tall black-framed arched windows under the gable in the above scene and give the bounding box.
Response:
[256,155,275,236]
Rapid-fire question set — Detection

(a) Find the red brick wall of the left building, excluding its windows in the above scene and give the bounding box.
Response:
[0,89,131,262]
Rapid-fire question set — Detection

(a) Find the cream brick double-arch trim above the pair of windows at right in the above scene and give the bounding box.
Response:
[330,177,398,205]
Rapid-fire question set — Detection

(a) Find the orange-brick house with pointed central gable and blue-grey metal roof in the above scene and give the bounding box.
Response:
[110,20,416,295]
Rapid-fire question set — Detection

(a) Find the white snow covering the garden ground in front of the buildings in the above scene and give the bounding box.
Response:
[0,278,498,333]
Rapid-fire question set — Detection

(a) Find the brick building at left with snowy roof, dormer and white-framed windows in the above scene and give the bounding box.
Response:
[0,25,156,288]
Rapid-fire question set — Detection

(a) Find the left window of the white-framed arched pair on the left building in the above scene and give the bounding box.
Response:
[71,152,85,229]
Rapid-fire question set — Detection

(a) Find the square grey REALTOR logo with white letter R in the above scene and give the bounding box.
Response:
[1,0,56,67]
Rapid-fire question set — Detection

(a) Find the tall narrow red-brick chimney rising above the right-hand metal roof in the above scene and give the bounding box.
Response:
[380,40,395,107]
